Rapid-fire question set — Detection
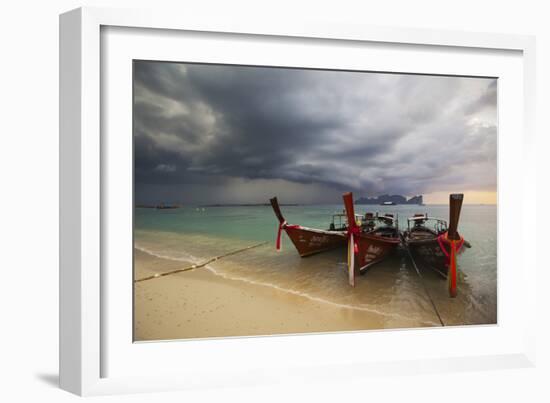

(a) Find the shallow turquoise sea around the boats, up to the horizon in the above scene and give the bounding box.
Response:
[134,205,497,328]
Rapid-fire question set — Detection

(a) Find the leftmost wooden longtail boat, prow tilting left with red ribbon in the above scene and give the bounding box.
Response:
[269,197,347,257]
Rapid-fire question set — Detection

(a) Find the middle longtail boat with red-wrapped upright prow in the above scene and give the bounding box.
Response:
[343,192,401,286]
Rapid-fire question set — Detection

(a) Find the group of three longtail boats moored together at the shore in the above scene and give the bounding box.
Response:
[270,192,470,297]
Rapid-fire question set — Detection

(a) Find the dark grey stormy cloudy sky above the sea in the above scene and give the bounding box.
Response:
[134,62,497,204]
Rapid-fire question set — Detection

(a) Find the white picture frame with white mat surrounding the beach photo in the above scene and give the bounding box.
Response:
[60,8,536,395]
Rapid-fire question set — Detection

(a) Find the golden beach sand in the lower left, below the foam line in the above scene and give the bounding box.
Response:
[134,249,402,341]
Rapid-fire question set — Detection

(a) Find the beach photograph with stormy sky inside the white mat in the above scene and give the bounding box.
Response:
[133,60,497,341]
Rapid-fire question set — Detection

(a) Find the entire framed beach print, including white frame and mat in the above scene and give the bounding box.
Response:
[60,9,535,394]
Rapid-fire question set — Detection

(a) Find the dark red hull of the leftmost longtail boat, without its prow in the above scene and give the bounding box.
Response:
[284,226,347,257]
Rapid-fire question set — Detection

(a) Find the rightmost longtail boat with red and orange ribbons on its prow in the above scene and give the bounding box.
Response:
[402,194,470,297]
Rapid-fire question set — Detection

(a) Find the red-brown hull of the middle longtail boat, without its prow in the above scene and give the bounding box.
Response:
[355,234,400,273]
